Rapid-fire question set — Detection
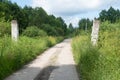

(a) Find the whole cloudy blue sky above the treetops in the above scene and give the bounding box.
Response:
[11,0,120,27]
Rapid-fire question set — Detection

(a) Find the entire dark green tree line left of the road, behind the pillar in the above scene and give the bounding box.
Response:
[0,0,68,36]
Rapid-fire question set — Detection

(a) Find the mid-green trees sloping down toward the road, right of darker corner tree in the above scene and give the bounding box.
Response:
[23,6,67,36]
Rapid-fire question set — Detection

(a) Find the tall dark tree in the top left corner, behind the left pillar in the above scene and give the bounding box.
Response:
[0,0,28,32]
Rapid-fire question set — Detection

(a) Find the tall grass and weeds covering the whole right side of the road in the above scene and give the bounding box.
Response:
[72,22,120,80]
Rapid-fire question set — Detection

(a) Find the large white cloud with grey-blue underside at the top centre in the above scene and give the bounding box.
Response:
[33,0,101,15]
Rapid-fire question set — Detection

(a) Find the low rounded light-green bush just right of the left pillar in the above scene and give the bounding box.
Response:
[23,26,47,37]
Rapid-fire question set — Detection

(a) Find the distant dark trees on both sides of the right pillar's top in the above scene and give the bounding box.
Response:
[78,7,120,31]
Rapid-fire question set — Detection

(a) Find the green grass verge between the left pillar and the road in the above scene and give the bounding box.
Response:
[0,36,63,80]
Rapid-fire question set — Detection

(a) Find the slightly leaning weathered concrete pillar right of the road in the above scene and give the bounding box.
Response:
[91,20,100,45]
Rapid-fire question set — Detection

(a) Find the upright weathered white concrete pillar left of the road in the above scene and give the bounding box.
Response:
[11,20,19,41]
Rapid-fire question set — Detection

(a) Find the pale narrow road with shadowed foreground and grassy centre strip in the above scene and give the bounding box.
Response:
[5,39,79,80]
